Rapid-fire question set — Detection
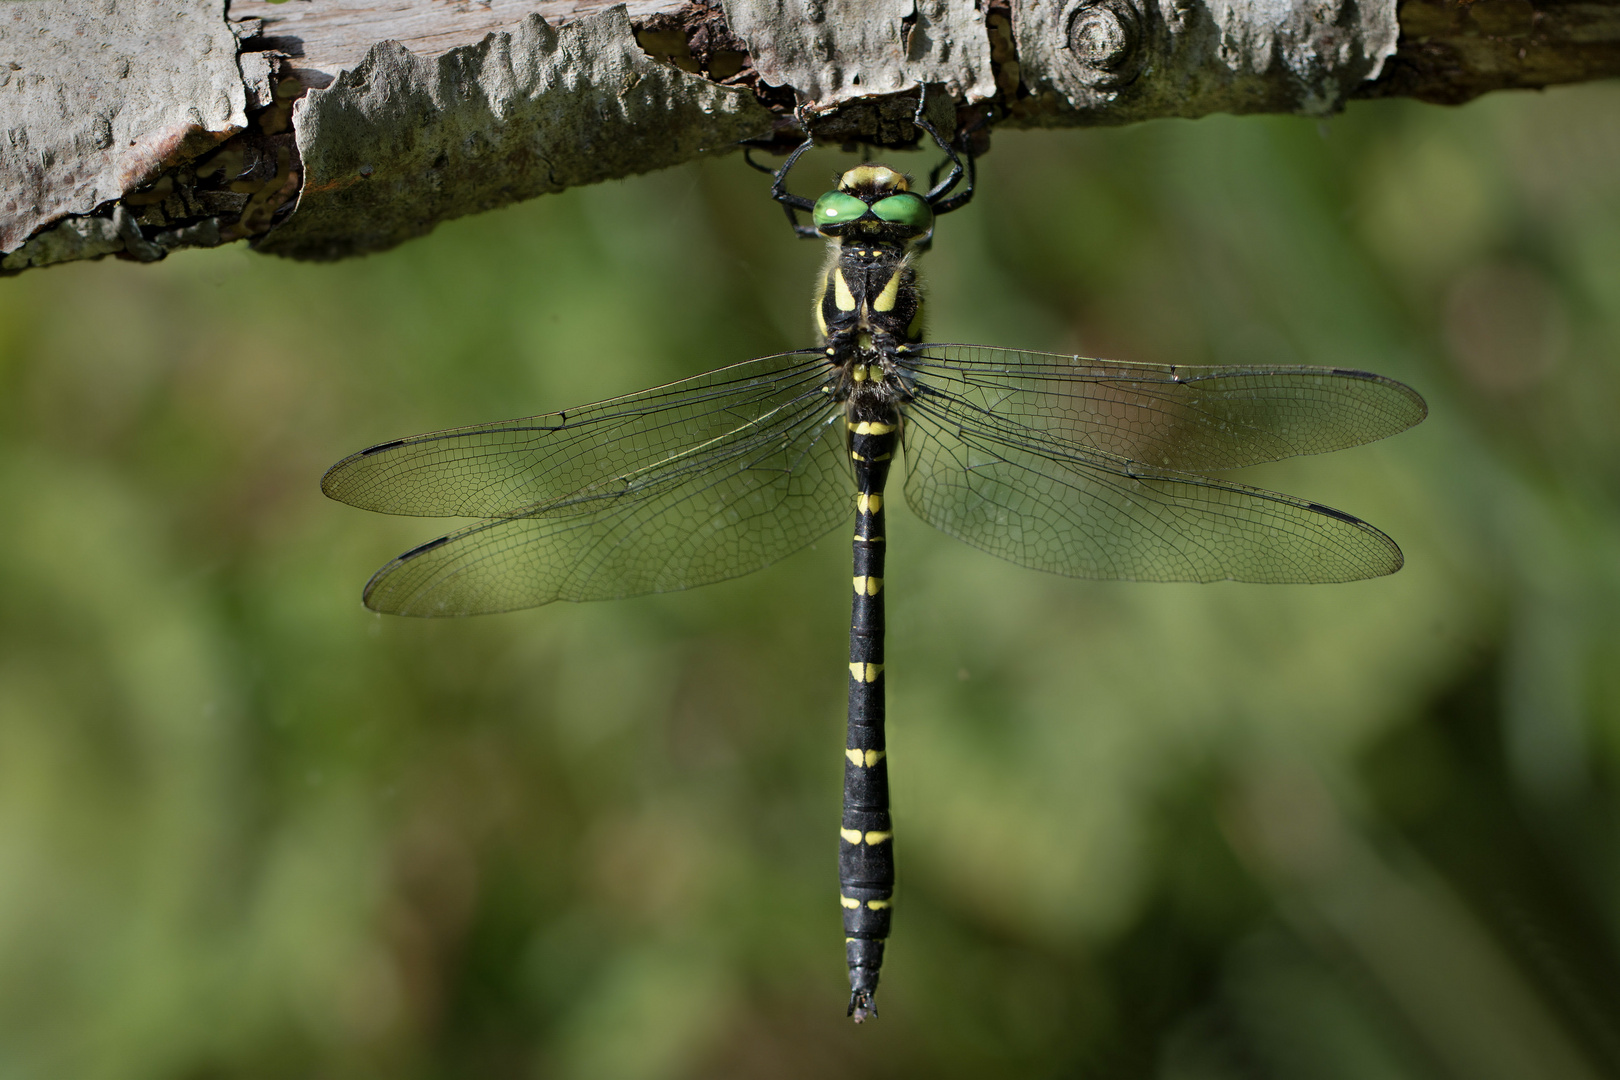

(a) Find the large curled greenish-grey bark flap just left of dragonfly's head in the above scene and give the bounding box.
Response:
[259,8,771,257]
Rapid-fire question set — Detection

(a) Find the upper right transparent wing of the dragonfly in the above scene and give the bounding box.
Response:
[904,345,1427,473]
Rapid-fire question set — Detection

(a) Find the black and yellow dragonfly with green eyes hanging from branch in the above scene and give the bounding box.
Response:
[321,93,1427,1023]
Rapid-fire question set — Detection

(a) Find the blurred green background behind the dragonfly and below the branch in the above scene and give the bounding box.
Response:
[0,84,1620,1080]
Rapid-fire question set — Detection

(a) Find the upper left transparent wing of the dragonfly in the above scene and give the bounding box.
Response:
[321,351,828,518]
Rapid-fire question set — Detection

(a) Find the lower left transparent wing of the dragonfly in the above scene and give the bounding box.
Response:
[365,392,852,615]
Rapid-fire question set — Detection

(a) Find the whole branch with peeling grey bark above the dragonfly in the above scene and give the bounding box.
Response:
[0,0,1620,272]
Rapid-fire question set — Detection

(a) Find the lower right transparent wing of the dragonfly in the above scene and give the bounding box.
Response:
[906,387,1401,583]
